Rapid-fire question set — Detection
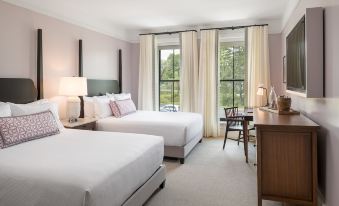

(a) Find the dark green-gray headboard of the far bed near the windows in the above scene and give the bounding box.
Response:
[87,79,120,97]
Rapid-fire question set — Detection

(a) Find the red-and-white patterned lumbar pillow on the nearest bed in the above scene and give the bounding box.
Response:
[0,111,60,147]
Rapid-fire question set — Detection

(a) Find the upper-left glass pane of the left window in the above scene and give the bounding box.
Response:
[160,49,173,80]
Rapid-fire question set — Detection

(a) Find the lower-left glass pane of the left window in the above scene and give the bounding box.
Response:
[160,82,173,112]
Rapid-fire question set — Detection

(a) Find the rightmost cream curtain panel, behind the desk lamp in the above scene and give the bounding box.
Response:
[247,26,270,107]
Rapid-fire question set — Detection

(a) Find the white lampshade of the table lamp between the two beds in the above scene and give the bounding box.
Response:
[59,77,87,96]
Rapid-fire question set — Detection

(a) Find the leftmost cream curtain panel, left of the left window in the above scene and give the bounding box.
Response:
[138,35,154,110]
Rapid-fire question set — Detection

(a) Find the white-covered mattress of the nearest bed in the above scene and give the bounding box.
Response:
[0,129,164,206]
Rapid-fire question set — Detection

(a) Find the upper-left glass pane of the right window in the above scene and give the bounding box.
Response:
[220,44,233,80]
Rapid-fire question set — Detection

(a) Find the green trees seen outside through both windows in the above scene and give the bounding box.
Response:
[160,42,246,111]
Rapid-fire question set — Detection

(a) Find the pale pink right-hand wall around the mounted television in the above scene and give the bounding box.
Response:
[271,0,339,206]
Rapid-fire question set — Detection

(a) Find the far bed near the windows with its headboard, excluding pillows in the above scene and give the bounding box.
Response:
[83,79,203,164]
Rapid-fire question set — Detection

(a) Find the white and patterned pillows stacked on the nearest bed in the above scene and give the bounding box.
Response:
[0,100,64,148]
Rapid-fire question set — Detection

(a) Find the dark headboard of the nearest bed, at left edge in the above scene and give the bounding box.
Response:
[0,78,38,104]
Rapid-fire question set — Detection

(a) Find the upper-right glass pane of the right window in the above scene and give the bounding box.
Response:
[234,46,245,79]
